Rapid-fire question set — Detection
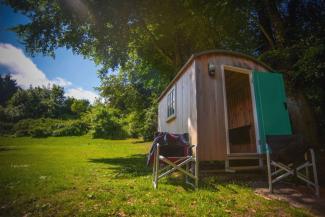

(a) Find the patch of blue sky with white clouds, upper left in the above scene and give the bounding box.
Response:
[0,4,100,101]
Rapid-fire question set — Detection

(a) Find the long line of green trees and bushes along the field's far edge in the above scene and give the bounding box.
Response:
[0,75,153,139]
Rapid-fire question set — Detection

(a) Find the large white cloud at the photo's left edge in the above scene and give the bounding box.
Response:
[0,43,71,89]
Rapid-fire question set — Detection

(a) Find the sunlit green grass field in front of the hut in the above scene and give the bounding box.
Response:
[0,136,310,216]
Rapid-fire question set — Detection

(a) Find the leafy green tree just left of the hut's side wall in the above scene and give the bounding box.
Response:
[99,55,161,140]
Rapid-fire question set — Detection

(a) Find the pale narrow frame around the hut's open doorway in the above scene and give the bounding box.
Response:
[221,64,261,155]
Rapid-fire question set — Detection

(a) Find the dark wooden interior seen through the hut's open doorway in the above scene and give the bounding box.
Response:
[224,68,256,154]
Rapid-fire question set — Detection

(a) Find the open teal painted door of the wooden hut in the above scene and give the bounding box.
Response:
[253,71,292,153]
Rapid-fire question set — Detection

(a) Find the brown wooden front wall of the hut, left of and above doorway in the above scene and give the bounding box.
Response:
[195,53,267,161]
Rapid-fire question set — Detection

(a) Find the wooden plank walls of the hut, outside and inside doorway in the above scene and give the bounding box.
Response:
[158,51,270,161]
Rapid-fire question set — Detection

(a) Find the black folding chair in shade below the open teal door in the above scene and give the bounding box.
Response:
[266,135,319,196]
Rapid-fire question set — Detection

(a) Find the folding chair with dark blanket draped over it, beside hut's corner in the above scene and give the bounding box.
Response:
[147,133,199,189]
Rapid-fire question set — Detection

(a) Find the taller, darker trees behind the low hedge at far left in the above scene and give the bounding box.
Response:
[0,85,90,122]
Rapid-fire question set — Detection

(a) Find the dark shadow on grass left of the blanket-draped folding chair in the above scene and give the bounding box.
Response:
[89,154,152,178]
